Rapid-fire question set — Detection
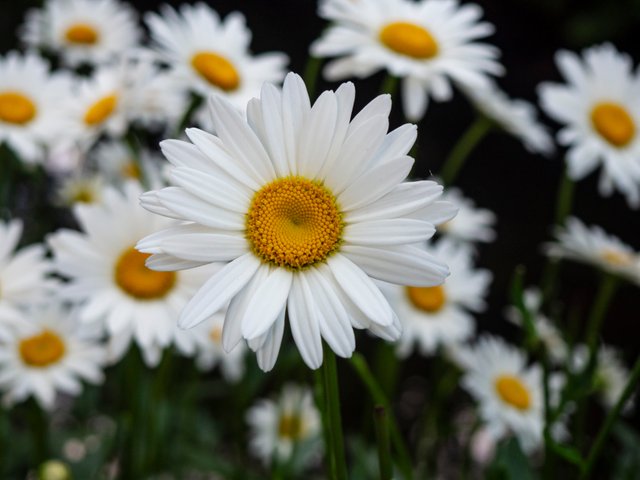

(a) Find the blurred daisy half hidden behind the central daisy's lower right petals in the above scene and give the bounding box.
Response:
[383,238,491,357]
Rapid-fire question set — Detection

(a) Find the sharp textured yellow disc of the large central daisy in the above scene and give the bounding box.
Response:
[246,177,343,269]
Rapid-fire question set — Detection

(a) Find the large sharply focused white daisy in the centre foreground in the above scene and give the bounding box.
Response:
[138,74,455,370]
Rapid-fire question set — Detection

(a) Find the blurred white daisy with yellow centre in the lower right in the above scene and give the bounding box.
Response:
[459,336,544,452]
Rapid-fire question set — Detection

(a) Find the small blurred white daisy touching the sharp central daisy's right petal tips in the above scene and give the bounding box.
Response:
[438,188,496,242]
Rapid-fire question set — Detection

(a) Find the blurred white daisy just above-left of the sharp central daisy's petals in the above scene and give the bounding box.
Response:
[145,3,288,115]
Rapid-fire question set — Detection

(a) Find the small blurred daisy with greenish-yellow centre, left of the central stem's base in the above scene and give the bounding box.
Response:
[246,384,322,465]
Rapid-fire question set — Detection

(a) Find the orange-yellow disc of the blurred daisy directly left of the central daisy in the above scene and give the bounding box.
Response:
[114,248,176,300]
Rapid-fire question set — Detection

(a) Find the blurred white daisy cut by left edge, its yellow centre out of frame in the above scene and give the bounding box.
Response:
[0,220,55,339]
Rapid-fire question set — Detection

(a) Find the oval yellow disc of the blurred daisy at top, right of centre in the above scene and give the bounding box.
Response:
[380,22,439,60]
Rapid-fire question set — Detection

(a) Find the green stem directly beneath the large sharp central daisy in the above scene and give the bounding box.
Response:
[322,344,348,480]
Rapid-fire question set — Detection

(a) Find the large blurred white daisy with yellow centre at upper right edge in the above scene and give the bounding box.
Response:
[539,44,640,208]
